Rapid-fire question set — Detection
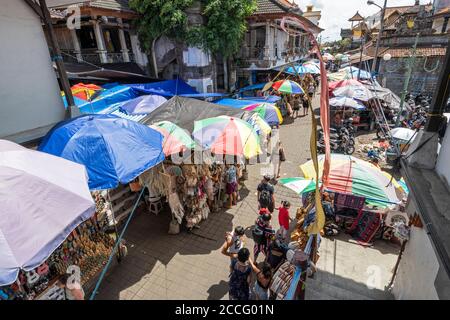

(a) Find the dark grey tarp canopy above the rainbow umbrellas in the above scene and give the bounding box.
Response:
[140,96,246,132]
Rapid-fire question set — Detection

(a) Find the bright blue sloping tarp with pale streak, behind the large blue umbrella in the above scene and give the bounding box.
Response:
[78,85,141,113]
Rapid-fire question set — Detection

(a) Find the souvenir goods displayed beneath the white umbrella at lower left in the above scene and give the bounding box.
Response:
[0,192,116,300]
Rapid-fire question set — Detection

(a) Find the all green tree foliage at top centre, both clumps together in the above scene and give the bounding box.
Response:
[129,0,257,57]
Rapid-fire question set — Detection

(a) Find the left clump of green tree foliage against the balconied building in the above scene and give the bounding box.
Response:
[129,0,194,52]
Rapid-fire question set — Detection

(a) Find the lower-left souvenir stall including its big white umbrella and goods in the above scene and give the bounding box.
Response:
[0,140,119,300]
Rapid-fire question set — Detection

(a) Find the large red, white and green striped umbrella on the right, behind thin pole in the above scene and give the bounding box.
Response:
[300,154,404,207]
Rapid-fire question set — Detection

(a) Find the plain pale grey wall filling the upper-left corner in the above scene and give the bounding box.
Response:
[0,0,65,142]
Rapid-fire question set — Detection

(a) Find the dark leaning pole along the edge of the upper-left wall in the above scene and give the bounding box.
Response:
[39,0,76,119]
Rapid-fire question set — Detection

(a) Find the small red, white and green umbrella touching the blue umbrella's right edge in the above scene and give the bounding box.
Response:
[150,121,195,156]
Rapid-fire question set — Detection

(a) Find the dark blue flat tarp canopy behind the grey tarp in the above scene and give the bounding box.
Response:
[128,79,199,98]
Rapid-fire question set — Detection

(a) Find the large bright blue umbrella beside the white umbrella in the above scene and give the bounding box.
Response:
[39,114,164,190]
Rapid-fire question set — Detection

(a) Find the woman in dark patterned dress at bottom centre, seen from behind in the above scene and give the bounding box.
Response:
[228,248,252,300]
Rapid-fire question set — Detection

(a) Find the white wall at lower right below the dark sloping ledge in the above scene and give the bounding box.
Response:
[392,227,439,300]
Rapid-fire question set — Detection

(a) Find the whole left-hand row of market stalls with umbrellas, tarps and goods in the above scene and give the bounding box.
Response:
[0,74,310,300]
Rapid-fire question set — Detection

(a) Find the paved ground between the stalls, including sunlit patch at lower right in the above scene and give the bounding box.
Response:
[97,97,395,300]
